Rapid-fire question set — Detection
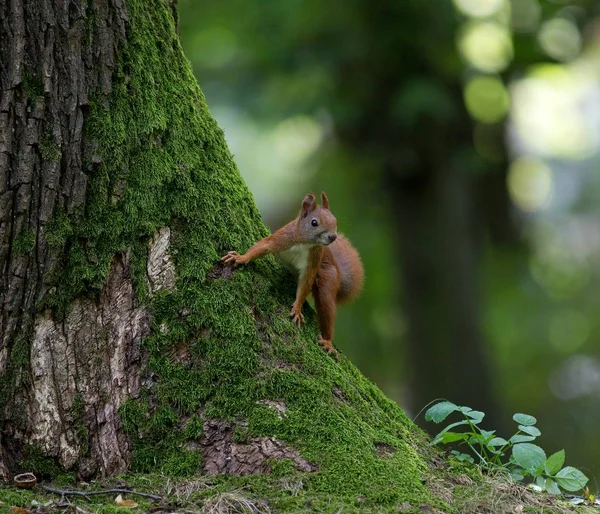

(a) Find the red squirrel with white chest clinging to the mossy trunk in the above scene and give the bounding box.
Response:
[221,193,364,357]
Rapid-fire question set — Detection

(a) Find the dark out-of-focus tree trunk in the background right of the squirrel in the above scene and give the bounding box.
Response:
[326,0,509,423]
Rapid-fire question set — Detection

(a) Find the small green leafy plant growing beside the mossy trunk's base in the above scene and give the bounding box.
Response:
[425,401,588,494]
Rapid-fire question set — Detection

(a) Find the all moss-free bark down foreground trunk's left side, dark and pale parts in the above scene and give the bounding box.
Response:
[0,0,127,473]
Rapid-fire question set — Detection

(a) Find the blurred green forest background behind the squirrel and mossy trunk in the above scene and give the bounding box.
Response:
[179,0,600,484]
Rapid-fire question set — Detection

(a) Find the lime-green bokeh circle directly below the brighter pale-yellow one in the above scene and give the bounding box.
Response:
[465,76,509,123]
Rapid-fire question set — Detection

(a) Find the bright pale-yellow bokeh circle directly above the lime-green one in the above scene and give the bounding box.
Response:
[458,21,513,73]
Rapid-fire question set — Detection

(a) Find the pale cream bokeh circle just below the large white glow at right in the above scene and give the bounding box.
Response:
[508,157,553,212]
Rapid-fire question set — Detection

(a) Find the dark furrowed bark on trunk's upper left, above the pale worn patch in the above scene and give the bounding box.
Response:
[0,0,127,350]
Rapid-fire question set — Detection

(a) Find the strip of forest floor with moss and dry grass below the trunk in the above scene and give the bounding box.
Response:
[0,468,600,514]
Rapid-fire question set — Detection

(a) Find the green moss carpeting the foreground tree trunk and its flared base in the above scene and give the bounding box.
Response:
[0,0,596,513]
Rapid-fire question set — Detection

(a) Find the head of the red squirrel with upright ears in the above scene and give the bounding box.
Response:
[298,193,337,246]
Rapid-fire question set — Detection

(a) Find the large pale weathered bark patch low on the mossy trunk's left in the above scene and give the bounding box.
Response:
[27,255,150,477]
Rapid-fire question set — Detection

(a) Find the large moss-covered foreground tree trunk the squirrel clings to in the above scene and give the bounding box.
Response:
[0,0,450,506]
